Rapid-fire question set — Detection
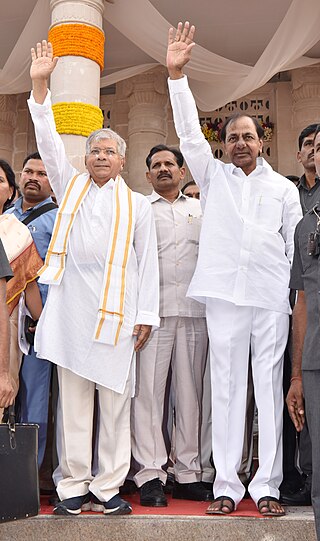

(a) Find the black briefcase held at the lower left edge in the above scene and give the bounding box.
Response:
[0,406,40,522]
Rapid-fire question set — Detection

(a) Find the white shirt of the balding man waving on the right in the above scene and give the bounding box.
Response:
[169,77,301,313]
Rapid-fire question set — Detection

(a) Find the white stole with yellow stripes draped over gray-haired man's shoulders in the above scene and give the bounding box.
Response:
[39,174,135,345]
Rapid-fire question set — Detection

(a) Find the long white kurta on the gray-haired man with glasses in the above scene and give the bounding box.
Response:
[28,93,159,393]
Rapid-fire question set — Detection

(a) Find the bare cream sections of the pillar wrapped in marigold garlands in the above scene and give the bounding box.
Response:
[50,0,104,171]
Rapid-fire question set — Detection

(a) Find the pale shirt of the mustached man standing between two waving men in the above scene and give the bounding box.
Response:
[148,191,205,317]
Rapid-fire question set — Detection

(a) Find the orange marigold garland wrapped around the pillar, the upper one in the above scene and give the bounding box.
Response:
[48,24,104,70]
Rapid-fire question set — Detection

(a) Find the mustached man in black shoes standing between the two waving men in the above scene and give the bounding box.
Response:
[132,145,212,506]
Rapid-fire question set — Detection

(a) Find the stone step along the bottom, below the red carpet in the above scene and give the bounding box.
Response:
[0,507,316,541]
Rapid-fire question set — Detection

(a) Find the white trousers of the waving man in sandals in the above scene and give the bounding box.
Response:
[207,298,289,505]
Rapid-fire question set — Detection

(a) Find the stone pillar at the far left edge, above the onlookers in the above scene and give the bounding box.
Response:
[0,94,17,164]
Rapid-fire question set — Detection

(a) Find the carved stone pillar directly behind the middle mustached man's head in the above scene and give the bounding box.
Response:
[117,67,168,194]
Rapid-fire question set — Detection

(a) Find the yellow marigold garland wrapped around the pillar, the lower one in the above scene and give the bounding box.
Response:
[52,102,103,137]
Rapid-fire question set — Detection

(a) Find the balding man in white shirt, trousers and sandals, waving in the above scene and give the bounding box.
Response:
[167,22,301,516]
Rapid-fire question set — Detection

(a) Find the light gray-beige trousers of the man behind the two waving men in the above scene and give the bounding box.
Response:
[131,317,208,487]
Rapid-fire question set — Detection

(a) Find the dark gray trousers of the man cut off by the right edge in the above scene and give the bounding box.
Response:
[302,370,320,541]
